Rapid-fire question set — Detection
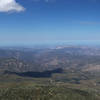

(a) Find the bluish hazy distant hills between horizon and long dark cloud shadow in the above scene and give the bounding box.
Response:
[0,46,100,72]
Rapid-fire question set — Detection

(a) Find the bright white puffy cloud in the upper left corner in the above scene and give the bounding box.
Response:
[0,0,25,12]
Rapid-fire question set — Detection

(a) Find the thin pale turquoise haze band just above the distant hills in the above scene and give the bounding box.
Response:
[0,40,100,47]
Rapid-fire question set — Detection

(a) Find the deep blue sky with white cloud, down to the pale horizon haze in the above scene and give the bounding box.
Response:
[0,0,100,45]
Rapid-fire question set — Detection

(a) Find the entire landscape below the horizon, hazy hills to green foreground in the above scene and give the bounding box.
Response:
[0,46,100,100]
